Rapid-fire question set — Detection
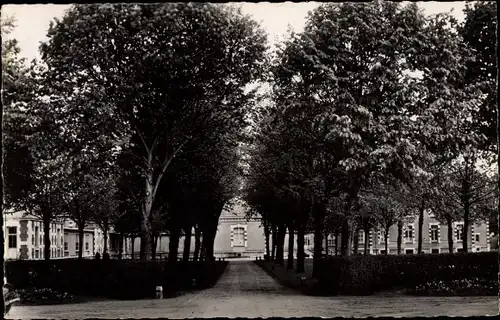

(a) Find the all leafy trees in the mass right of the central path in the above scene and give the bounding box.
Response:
[245,1,498,274]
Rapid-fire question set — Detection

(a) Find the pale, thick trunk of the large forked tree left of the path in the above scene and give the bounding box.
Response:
[139,170,154,260]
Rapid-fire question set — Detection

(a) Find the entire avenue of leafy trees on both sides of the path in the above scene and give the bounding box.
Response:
[2,1,498,266]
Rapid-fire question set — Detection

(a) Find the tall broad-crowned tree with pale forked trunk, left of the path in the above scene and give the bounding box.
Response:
[42,3,265,259]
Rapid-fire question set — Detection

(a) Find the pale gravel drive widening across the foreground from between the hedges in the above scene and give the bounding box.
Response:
[7,261,499,319]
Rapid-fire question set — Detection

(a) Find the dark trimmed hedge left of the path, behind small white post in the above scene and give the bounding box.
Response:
[5,260,227,299]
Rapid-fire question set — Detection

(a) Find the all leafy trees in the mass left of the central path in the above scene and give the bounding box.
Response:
[2,3,267,260]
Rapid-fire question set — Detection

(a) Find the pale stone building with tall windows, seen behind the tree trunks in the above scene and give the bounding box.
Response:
[4,203,491,260]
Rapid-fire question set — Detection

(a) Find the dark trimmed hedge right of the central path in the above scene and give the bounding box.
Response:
[314,252,498,295]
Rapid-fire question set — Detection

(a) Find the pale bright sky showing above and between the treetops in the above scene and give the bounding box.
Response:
[2,1,472,60]
